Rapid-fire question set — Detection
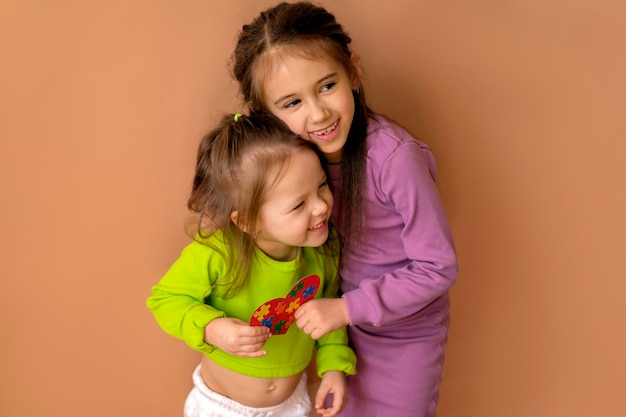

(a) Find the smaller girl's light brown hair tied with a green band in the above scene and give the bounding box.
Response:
[187,114,332,294]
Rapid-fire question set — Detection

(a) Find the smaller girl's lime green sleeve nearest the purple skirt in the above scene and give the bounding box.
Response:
[316,250,356,378]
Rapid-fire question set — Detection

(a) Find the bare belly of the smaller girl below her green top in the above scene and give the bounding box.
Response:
[201,356,302,408]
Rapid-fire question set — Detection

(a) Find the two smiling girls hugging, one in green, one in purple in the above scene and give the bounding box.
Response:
[147,2,458,417]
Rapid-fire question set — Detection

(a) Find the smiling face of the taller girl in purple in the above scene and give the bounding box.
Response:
[263,53,354,163]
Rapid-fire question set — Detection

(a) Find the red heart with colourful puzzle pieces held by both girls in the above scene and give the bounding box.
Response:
[250,275,320,335]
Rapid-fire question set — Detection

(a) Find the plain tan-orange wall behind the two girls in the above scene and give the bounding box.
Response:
[0,0,626,417]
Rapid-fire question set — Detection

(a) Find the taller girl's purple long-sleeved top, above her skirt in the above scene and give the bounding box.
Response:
[330,116,458,331]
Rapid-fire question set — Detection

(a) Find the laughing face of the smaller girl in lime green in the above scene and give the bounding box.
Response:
[256,149,333,261]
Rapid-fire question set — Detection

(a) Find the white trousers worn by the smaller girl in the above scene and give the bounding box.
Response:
[184,365,311,417]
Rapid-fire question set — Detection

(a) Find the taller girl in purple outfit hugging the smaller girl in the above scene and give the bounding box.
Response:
[232,2,458,417]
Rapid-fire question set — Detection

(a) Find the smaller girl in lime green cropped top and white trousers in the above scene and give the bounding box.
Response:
[147,114,356,417]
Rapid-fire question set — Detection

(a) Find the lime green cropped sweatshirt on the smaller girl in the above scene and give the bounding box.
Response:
[147,232,356,378]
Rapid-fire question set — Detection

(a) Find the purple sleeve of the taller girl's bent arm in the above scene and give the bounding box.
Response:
[343,141,458,326]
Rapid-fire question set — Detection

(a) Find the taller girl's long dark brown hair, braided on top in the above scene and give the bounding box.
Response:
[231,2,373,258]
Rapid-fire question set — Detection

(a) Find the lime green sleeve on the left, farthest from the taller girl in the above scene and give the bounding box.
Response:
[146,242,225,353]
